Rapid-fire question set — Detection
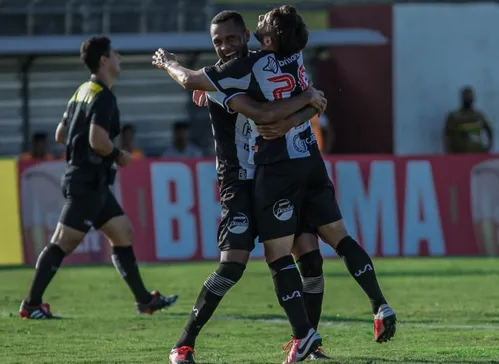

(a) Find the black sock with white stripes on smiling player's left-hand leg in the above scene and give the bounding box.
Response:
[175,262,246,348]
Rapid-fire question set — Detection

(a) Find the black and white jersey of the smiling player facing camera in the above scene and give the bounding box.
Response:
[206,91,255,186]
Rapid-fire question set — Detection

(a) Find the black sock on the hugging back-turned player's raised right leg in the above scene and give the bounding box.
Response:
[336,236,386,314]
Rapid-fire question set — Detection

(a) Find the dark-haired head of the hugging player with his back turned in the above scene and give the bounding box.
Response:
[255,5,308,56]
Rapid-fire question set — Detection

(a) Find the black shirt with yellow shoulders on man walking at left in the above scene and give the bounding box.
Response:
[66,80,120,177]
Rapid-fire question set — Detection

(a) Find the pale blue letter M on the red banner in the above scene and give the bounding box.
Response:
[336,161,399,256]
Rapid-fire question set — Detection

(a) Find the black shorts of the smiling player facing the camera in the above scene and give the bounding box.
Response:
[218,180,256,252]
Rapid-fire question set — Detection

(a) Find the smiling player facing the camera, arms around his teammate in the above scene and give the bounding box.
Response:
[154,11,328,364]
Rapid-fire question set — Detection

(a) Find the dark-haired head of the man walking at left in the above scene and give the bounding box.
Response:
[80,36,121,78]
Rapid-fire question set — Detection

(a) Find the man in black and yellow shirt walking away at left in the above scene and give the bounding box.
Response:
[19,37,177,319]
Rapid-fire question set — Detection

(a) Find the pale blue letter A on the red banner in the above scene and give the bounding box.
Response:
[403,161,445,256]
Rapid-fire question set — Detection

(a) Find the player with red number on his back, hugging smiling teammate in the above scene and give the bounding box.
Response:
[153,5,396,354]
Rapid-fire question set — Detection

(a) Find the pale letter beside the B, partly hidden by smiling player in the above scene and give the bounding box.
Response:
[196,162,221,259]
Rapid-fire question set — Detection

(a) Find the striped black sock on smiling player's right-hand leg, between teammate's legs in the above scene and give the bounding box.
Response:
[297,249,324,330]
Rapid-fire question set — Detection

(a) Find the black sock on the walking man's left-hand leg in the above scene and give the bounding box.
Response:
[26,243,66,306]
